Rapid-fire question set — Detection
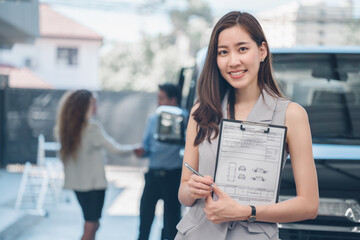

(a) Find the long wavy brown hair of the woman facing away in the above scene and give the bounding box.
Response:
[55,90,93,163]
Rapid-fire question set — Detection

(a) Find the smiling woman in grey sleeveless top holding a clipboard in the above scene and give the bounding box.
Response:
[175,12,319,240]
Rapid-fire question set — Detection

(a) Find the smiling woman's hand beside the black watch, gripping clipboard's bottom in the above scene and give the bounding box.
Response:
[204,184,251,224]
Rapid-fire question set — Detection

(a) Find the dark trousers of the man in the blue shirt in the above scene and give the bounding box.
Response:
[139,169,181,240]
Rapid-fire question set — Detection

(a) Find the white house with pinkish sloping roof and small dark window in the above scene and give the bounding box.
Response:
[0,4,102,90]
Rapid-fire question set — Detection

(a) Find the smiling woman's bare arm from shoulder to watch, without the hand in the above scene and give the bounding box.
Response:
[256,103,319,223]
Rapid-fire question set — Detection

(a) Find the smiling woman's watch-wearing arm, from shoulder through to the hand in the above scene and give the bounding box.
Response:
[205,103,319,223]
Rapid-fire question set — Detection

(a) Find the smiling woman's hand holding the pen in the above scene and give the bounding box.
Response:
[188,174,214,199]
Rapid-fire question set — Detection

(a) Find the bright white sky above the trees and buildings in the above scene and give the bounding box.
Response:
[44,0,360,42]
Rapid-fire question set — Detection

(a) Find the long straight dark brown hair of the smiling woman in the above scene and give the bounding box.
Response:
[193,11,283,146]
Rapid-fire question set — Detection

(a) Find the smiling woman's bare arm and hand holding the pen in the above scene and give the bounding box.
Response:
[179,105,213,206]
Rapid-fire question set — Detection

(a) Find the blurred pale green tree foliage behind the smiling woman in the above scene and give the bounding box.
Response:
[100,0,212,92]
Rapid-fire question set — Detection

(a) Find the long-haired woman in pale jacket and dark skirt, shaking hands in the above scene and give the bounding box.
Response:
[55,90,133,240]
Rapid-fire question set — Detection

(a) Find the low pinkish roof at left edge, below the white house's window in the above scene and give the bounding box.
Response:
[0,65,53,89]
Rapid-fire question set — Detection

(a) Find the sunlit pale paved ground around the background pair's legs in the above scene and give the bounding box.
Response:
[0,167,162,240]
